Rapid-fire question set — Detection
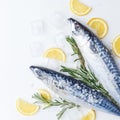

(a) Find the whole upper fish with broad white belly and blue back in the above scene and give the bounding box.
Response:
[68,18,120,104]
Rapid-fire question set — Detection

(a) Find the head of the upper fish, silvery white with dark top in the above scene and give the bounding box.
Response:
[68,18,91,46]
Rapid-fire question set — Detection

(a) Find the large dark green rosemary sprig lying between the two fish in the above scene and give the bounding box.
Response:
[61,37,117,104]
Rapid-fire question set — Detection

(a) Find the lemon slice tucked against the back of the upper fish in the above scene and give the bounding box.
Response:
[88,18,108,38]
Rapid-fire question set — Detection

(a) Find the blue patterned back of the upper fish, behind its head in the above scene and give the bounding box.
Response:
[89,36,120,91]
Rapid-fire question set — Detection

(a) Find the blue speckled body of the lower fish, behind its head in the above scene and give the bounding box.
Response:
[50,73,120,113]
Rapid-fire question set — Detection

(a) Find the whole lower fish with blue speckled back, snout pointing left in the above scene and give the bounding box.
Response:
[30,66,120,116]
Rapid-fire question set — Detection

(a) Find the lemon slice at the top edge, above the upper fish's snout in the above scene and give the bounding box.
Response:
[70,0,91,16]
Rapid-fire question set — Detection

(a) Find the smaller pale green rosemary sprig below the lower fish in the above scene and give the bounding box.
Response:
[32,93,80,120]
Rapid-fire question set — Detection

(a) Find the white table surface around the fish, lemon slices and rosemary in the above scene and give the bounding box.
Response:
[0,0,120,120]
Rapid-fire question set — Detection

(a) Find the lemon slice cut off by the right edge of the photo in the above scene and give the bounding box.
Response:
[113,35,120,57]
